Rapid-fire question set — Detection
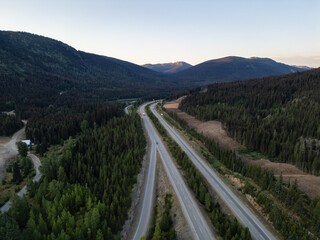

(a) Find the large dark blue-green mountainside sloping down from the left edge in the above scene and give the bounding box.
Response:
[0,31,174,109]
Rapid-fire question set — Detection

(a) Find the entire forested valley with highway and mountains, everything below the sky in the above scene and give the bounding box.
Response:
[0,30,320,240]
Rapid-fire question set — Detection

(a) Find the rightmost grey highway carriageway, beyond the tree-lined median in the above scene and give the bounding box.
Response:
[150,104,276,240]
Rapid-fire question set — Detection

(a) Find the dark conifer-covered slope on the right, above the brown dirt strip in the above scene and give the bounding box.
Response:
[180,68,320,175]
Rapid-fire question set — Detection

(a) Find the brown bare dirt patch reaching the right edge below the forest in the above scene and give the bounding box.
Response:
[251,159,320,197]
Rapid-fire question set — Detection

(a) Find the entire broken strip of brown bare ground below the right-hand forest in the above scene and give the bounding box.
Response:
[164,97,320,197]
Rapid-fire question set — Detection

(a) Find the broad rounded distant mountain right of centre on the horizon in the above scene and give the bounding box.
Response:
[172,56,301,85]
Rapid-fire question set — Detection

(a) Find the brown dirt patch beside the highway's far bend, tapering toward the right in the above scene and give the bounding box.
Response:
[164,97,241,150]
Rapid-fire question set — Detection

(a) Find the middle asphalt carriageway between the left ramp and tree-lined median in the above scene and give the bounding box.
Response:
[140,104,215,240]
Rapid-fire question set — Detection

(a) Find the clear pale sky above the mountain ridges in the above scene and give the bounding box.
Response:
[0,0,320,67]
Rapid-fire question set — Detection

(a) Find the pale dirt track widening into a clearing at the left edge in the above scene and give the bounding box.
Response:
[0,121,26,181]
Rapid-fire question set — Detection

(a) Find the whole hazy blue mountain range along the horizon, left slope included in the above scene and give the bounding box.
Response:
[0,31,312,110]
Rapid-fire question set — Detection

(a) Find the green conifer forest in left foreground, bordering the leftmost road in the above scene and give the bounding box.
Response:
[0,108,146,240]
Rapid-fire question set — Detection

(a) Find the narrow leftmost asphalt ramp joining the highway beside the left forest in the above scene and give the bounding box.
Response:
[131,104,157,240]
